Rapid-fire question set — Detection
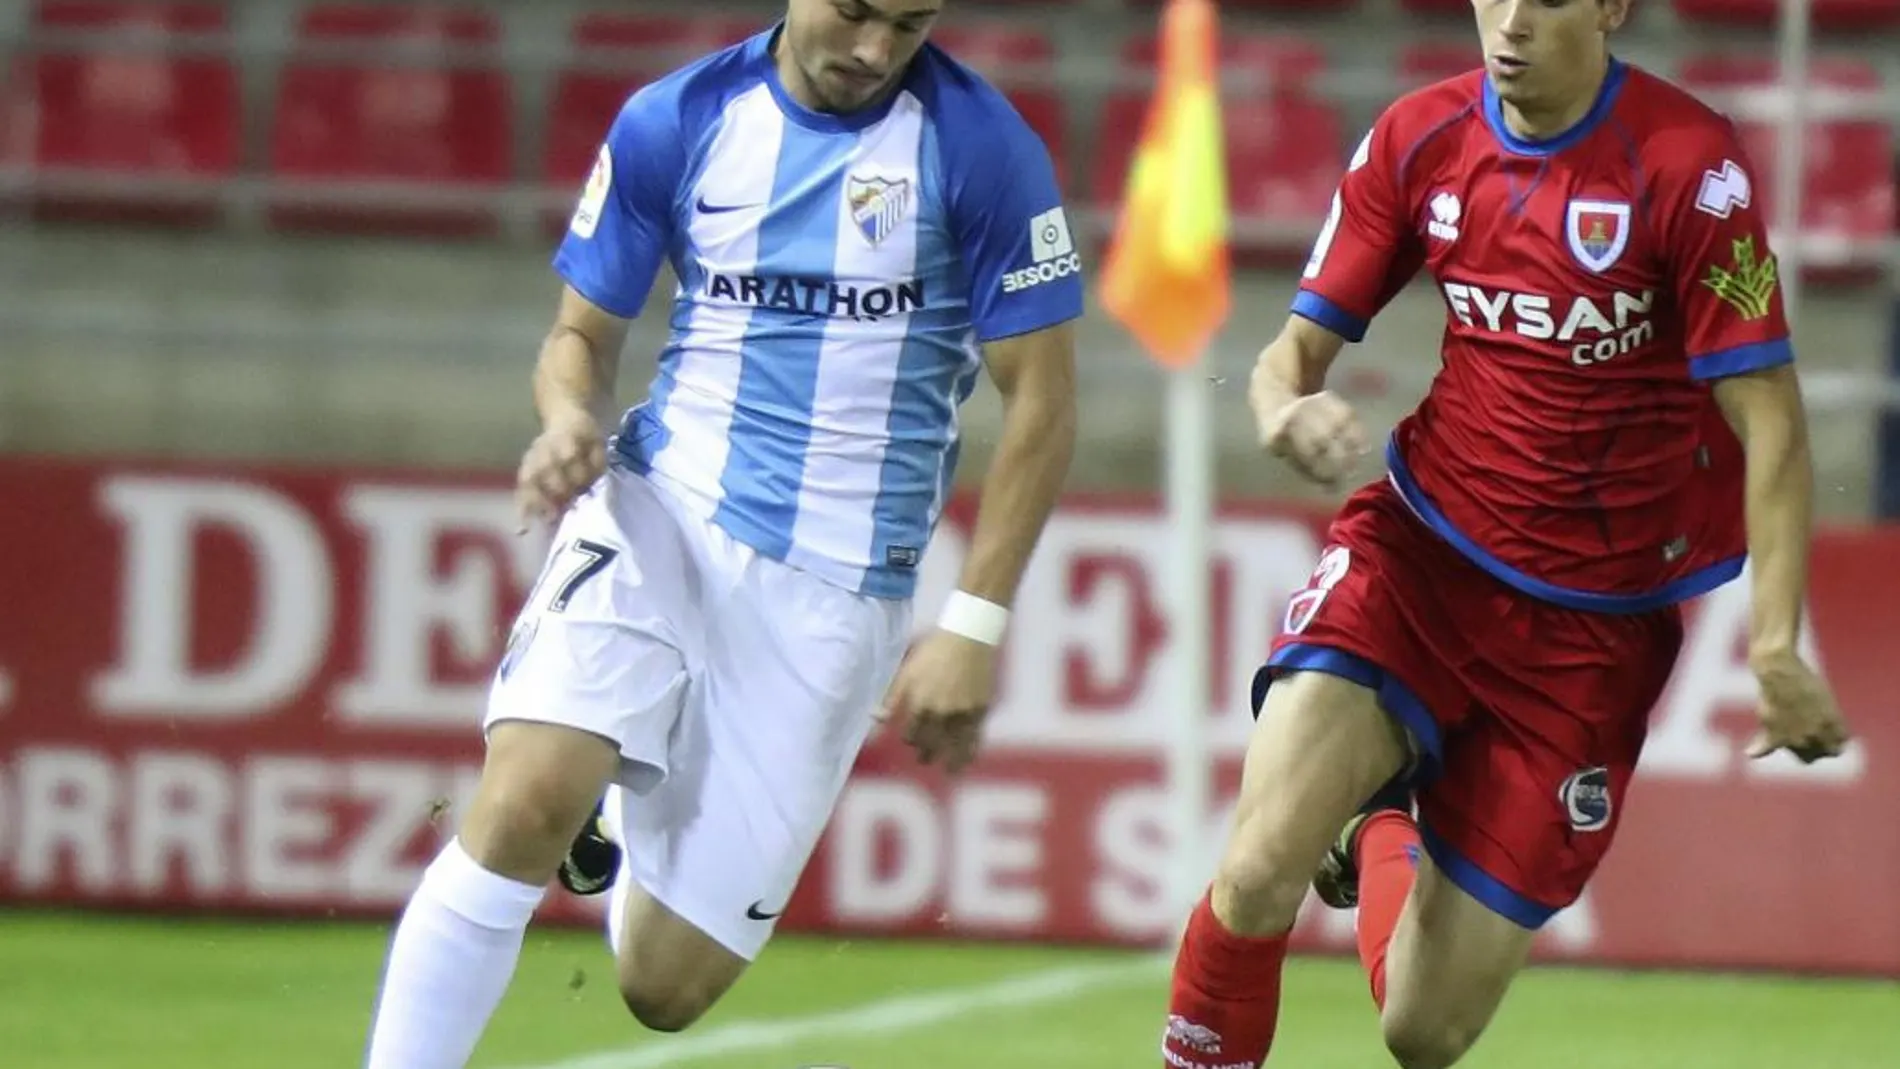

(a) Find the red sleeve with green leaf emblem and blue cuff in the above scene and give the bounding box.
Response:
[1657,125,1794,380]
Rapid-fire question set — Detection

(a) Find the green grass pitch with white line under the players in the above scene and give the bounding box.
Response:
[0,913,1900,1069]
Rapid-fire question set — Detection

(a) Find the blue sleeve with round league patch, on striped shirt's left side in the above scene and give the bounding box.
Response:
[555,85,686,319]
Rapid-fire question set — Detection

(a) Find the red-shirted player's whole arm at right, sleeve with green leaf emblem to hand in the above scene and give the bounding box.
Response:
[1657,129,1847,761]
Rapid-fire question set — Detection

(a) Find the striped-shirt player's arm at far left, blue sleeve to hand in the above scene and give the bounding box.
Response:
[515,85,686,520]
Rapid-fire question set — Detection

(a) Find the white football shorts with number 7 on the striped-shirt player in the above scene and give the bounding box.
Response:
[485,469,910,959]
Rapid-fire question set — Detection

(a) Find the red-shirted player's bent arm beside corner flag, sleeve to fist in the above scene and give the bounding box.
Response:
[1248,110,1421,486]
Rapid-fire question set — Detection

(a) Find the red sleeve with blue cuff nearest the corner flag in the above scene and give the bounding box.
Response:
[1294,110,1423,342]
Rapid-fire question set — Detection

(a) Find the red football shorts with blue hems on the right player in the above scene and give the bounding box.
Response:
[1254,482,1682,928]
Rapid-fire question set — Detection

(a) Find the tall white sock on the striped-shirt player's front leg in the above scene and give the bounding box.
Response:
[365,839,545,1069]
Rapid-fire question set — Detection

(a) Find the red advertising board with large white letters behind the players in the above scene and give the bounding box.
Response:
[0,459,1900,974]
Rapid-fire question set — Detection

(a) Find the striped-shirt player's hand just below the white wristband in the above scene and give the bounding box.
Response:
[880,630,996,775]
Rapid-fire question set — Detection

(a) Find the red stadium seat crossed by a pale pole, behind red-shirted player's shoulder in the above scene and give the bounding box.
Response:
[1680,55,1894,268]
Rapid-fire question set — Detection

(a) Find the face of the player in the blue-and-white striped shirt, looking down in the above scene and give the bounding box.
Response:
[779,0,942,112]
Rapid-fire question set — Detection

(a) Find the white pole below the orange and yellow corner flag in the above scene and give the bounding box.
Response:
[1165,357,1214,917]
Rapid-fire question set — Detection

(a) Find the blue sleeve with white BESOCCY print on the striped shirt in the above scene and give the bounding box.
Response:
[941,95,1083,342]
